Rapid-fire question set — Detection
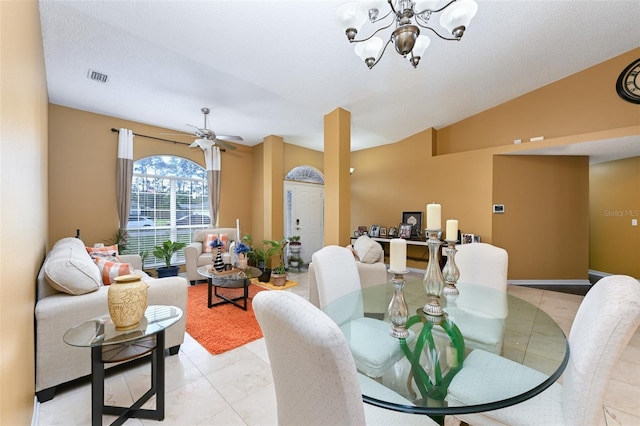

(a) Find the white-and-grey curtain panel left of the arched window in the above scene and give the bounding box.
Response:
[116,129,133,230]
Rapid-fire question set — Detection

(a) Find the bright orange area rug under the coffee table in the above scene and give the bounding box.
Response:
[187,283,266,355]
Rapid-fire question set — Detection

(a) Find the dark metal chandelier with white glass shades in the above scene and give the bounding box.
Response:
[337,0,478,69]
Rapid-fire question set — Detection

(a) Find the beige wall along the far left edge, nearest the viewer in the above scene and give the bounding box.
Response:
[0,1,48,425]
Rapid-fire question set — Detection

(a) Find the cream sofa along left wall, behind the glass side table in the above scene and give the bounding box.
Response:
[35,238,188,402]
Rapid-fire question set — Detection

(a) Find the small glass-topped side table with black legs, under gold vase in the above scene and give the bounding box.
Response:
[63,305,182,426]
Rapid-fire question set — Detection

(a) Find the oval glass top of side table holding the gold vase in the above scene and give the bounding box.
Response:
[63,305,182,347]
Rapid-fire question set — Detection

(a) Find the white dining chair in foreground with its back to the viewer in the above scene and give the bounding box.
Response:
[253,291,437,426]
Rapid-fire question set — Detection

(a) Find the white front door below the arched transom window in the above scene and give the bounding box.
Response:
[284,181,324,264]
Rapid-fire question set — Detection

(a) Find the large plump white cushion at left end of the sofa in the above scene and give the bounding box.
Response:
[44,238,102,295]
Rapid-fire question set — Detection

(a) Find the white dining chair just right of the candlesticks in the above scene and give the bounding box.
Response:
[445,243,509,354]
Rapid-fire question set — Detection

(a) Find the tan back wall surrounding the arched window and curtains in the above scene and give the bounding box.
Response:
[49,105,254,248]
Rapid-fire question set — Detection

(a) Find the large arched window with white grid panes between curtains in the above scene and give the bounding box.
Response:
[126,155,211,267]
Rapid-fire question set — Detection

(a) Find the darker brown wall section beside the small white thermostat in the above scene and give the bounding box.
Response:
[492,155,589,280]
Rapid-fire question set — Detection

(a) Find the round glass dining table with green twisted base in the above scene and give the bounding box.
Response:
[323,279,569,416]
